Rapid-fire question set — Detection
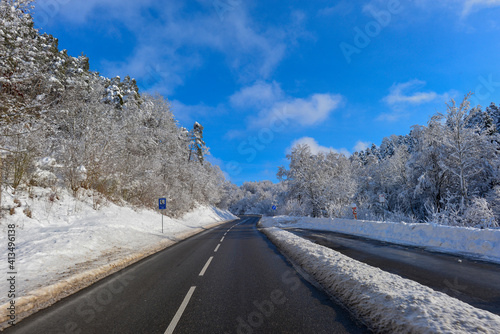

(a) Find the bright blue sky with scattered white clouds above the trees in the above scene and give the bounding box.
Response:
[34,0,500,184]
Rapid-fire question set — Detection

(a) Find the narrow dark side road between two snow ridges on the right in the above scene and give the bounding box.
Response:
[288,229,500,315]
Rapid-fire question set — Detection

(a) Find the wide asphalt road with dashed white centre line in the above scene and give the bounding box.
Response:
[5,217,367,334]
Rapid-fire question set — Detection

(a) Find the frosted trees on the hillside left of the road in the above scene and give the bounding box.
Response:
[0,0,226,216]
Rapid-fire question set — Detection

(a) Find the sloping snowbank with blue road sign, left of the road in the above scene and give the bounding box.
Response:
[0,188,237,328]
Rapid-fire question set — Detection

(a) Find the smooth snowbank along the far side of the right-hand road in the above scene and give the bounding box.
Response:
[264,216,500,263]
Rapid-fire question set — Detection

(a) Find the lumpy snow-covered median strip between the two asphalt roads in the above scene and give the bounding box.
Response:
[262,222,500,333]
